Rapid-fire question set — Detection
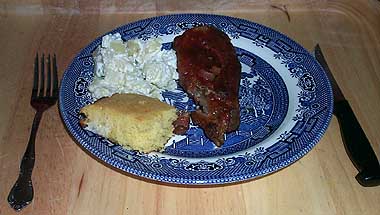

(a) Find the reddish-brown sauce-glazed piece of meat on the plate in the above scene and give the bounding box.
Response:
[173,26,241,146]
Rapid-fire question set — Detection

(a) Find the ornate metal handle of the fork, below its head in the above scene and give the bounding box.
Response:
[8,111,43,211]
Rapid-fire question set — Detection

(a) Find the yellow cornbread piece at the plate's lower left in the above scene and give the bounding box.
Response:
[80,94,177,153]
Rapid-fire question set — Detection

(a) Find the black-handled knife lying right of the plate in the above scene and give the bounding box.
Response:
[314,44,380,187]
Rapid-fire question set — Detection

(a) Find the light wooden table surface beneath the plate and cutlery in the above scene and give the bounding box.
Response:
[0,0,380,215]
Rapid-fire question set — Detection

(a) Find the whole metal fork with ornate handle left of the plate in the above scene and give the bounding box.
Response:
[8,53,58,211]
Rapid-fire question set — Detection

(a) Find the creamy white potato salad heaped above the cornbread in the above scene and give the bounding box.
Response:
[89,33,178,100]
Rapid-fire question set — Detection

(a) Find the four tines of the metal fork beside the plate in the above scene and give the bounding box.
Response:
[32,53,58,98]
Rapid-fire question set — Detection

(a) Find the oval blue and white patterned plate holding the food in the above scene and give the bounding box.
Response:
[59,14,333,184]
